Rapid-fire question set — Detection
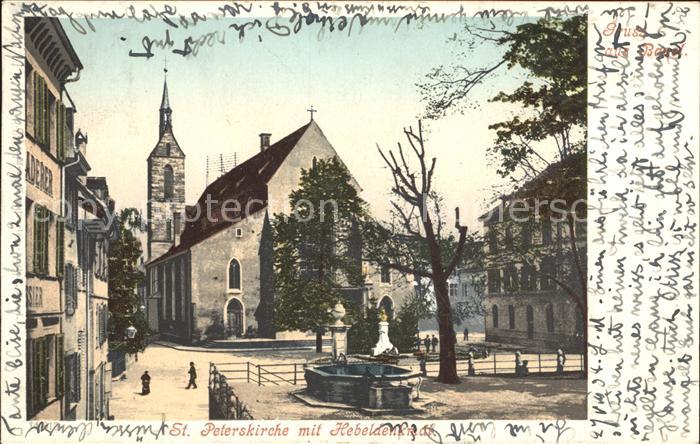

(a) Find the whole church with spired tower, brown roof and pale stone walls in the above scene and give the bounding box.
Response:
[146,80,414,342]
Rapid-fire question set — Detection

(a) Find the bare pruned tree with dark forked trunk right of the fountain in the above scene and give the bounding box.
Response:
[364,121,471,384]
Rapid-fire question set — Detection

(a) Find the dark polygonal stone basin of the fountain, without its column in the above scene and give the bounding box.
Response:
[304,362,421,409]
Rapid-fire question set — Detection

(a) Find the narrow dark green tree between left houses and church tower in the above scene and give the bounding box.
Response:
[108,208,150,353]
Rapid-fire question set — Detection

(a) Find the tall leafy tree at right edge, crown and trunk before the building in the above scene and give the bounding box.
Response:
[418,16,587,368]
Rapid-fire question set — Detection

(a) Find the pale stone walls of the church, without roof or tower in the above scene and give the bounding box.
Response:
[147,121,414,342]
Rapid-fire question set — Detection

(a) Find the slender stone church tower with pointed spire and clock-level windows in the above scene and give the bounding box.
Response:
[147,71,185,261]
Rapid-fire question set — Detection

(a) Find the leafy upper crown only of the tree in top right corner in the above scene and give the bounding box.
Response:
[418,16,587,182]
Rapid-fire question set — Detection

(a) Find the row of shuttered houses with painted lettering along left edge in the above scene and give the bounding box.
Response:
[25,18,118,420]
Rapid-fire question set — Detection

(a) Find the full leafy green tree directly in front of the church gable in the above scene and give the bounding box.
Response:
[273,158,367,352]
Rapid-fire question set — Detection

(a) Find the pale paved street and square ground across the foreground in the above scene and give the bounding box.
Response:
[110,344,586,420]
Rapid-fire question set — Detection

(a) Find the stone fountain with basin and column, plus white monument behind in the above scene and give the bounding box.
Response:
[295,302,422,411]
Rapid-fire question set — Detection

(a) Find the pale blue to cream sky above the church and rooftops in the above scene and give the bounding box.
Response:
[62,13,540,229]
